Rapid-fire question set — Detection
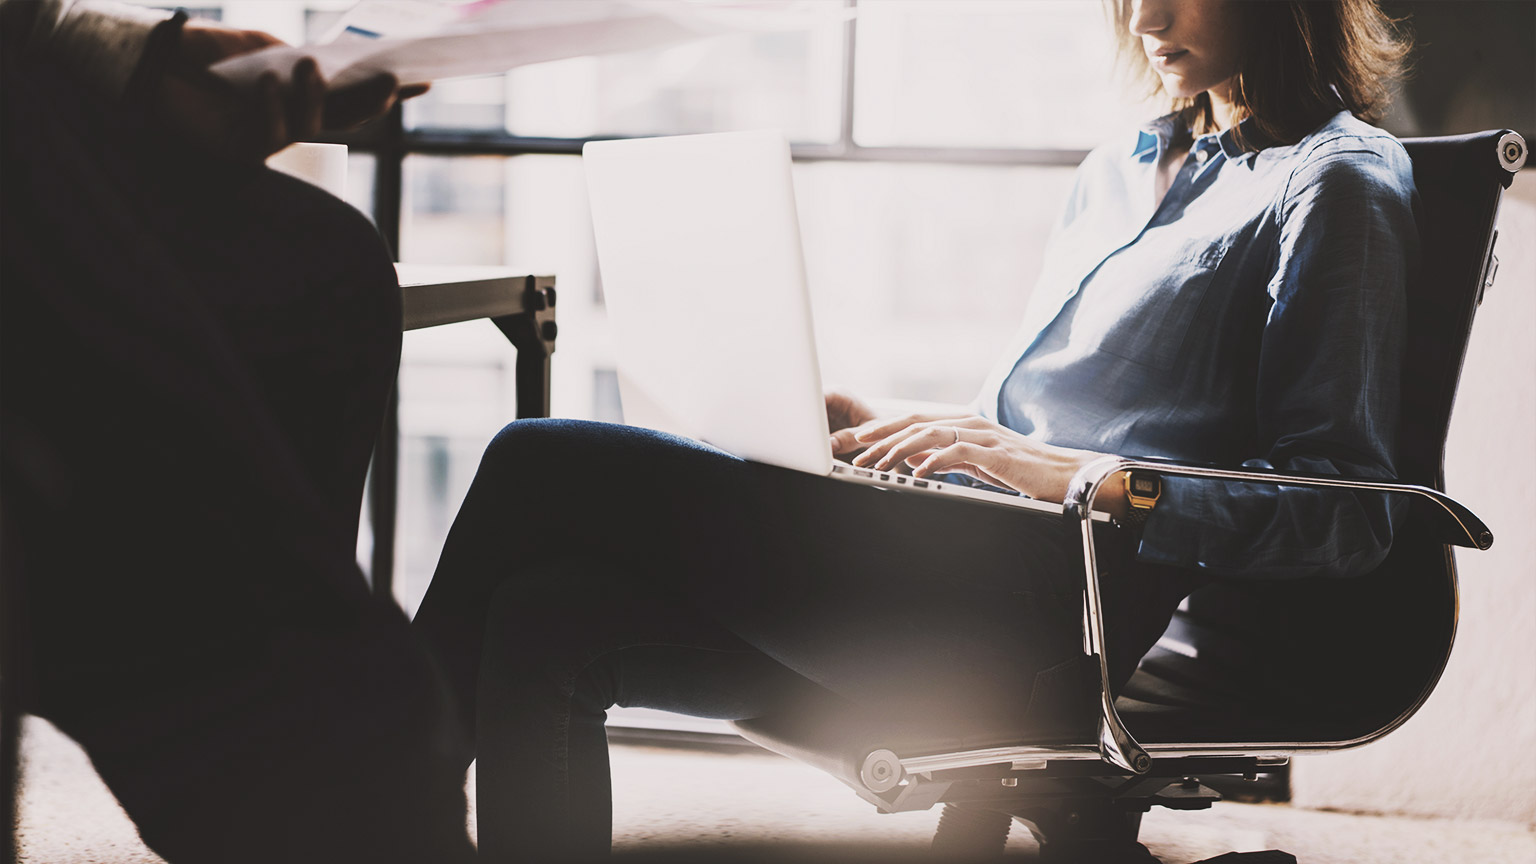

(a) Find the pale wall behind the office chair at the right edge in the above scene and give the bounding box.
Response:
[1292,171,1536,826]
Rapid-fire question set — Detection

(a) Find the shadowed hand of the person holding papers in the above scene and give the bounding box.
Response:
[151,20,427,161]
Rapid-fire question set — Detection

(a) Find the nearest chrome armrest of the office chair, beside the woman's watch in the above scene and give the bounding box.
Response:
[1064,457,1493,773]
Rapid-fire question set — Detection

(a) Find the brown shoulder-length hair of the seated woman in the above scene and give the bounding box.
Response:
[1106,0,1413,143]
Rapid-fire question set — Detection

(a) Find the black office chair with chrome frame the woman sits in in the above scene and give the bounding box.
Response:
[736,131,1525,864]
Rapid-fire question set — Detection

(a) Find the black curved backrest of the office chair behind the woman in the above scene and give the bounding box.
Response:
[1130,131,1525,743]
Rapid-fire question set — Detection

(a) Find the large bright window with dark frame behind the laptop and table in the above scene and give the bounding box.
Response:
[158,0,1144,612]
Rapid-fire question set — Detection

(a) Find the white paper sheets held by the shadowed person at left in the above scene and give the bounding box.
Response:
[210,0,852,89]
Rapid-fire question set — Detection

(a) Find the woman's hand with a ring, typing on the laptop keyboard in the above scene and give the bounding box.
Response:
[852,415,1118,509]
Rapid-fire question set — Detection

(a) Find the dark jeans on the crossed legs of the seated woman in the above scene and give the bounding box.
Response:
[415,420,1187,861]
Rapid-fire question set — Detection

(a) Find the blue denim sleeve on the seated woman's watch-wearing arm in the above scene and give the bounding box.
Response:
[1138,140,1418,578]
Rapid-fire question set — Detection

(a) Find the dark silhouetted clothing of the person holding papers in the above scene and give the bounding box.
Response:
[0,3,472,862]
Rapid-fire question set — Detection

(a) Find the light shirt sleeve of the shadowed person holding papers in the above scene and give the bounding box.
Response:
[11,0,169,98]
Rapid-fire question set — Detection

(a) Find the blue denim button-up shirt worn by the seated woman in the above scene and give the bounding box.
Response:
[978,112,1418,577]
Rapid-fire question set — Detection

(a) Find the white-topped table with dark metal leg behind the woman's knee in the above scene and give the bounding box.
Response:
[369,264,559,596]
